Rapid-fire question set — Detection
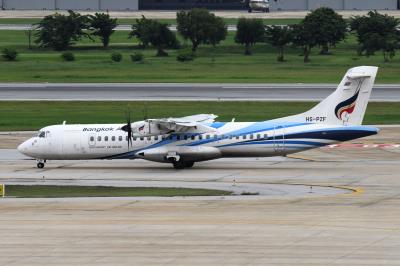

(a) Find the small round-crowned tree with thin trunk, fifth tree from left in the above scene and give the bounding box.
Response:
[235,18,265,55]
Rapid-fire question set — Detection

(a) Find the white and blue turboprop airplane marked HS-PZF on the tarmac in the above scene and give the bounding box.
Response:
[18,66,379,169]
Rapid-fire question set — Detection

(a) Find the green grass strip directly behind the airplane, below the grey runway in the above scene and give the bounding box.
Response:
[0,102,400,131]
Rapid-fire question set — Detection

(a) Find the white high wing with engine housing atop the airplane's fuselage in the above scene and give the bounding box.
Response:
[146,114,217,132]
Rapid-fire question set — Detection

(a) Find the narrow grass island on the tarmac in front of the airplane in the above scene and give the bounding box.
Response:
[6,185,232,198]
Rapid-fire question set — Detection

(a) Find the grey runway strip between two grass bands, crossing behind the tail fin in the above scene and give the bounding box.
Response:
[0,83,400,102]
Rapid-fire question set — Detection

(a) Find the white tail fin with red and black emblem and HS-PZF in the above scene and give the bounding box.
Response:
[283,66,378,125]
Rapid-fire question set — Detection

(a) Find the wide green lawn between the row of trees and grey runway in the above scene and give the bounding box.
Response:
[0,31,400,83]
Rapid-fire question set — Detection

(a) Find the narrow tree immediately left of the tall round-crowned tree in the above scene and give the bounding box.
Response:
[292,22,317,63]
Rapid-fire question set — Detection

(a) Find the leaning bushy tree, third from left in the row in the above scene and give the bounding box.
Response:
[129,16,179,56]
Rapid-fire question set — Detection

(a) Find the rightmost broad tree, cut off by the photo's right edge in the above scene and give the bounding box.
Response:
[350,11,400,62]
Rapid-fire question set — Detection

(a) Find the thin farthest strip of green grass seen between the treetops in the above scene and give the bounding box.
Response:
[0,18,301,25]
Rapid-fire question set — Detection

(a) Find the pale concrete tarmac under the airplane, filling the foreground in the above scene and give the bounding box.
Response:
[0,127,400,265]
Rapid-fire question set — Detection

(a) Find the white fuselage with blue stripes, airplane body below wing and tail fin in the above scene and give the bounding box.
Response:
[18,121,378,162]
